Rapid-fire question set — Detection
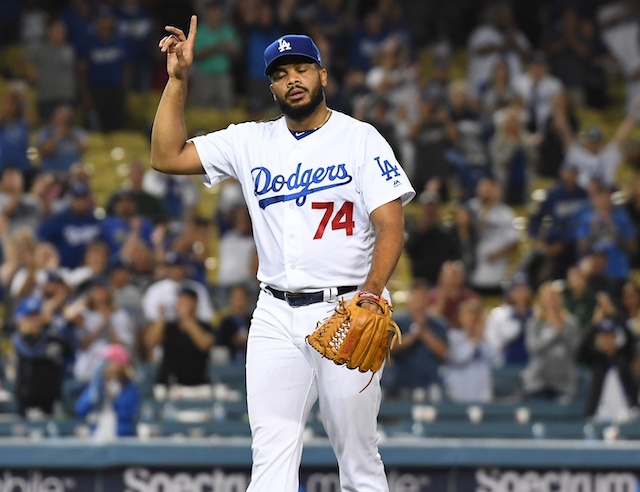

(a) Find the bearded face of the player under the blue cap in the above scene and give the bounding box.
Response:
[271,62,327,121]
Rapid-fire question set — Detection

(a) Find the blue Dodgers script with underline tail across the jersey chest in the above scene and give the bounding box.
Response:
[251,163,353,209]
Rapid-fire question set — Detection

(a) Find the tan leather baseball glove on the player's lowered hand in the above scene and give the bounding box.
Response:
[307,292,402,388]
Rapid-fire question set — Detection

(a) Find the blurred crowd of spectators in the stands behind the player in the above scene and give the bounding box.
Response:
[0,0,640,435]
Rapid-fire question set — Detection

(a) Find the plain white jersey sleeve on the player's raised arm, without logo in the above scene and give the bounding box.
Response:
[190,125,240,186]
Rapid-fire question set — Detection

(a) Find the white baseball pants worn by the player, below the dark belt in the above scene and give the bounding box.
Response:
[247,291,389,492]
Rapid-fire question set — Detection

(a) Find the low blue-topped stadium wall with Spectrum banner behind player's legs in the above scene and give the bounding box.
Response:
[0,438,640,492]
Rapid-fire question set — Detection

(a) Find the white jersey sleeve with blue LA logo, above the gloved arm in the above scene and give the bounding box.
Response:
[358,126,416,214]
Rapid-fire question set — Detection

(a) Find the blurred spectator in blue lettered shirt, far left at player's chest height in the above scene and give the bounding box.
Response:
[38,181,101,268]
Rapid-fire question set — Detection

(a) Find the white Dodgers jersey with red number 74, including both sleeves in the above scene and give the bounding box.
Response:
[192,111,415,292]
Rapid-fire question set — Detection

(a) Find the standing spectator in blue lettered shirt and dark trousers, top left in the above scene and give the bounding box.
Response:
[78,9,130,132]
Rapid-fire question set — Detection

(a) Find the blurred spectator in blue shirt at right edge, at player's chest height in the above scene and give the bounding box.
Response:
[577,185,636,290]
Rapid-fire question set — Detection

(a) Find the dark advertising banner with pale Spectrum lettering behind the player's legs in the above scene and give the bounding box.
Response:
[0,466,640,492]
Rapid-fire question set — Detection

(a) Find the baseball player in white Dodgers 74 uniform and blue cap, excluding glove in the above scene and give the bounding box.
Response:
[151,16,415,492]
